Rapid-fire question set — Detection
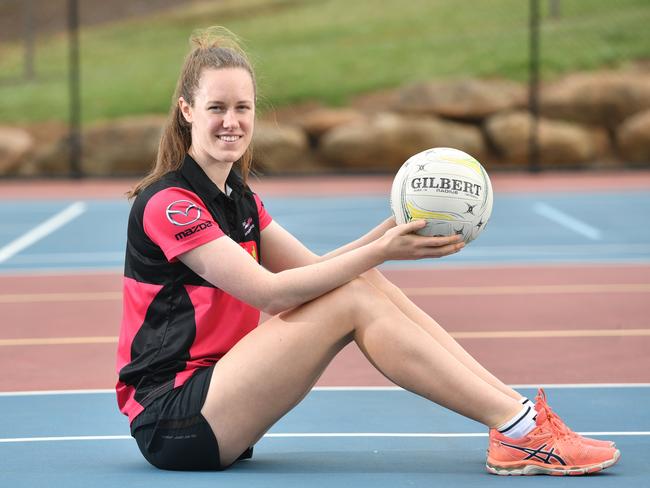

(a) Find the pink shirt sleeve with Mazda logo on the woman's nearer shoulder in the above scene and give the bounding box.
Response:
[143,187,225,261]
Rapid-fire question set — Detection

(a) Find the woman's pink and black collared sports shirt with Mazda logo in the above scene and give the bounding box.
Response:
[116,156,271,421]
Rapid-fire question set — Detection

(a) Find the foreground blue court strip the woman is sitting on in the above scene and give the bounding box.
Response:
[0,385,650,488]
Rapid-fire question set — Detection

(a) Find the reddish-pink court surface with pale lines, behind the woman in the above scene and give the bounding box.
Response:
[0,171,650,391]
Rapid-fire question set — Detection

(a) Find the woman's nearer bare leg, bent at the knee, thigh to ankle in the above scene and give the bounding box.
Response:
[202,278,521,466]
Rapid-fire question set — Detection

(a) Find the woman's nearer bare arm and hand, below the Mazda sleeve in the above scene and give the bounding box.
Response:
[179,221,463,314]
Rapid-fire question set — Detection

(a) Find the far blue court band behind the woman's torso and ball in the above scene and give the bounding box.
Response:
[0,191,650,273]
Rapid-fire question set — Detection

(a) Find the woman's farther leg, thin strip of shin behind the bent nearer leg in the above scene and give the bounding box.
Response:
[363,269,523,400]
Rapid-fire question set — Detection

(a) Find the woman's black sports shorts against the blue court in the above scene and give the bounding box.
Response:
[131,366,253,471]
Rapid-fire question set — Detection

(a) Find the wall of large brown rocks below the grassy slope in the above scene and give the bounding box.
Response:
[0,67,650,176]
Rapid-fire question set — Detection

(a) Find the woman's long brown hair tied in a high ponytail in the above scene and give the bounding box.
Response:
[127,26,257,198]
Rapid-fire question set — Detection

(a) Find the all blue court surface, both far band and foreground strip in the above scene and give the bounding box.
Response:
[0,186,650,488]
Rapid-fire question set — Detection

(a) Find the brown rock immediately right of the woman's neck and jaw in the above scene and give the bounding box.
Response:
[253,120,316,173]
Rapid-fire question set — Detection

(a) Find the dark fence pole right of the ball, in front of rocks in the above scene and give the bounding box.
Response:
[528,0,541,173]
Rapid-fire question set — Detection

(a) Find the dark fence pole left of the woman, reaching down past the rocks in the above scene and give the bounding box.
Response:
[68,0,82,178]
